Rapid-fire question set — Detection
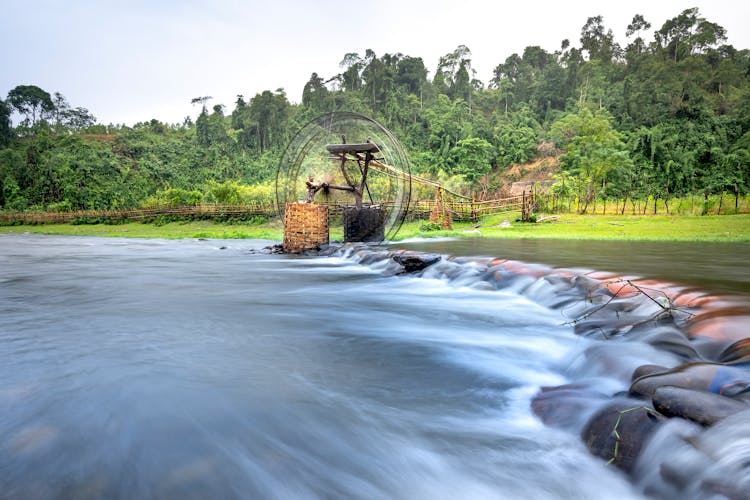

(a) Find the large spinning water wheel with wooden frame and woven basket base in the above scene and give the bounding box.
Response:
[276,112,411,251]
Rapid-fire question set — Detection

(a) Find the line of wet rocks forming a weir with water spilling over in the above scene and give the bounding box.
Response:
[300,241,750,499]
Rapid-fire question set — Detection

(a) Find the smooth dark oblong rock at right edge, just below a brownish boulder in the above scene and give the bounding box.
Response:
[653,386,750,425]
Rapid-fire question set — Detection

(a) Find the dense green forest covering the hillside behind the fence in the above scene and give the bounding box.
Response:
[0,9,750,211]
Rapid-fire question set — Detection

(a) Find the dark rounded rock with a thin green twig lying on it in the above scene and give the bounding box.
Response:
[581,399,664,473]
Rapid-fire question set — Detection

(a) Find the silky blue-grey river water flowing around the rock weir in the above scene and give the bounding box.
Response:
[0,235,750,499]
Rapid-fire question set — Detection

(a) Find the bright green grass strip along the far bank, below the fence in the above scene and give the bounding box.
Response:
[0,214,750,242]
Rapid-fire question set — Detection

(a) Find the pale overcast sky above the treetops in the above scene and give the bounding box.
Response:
[0,0,750,125]
